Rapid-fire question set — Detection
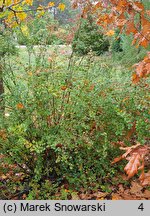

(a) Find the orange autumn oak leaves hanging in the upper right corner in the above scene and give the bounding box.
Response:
[73,0,150,83]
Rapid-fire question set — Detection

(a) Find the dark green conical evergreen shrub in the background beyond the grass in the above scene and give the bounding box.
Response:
[72,16,109,55]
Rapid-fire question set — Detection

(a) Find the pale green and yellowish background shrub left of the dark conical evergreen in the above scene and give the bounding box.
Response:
[15,13,64,45]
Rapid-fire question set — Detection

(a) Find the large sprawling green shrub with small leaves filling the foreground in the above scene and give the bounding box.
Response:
[0,49,148,199]
